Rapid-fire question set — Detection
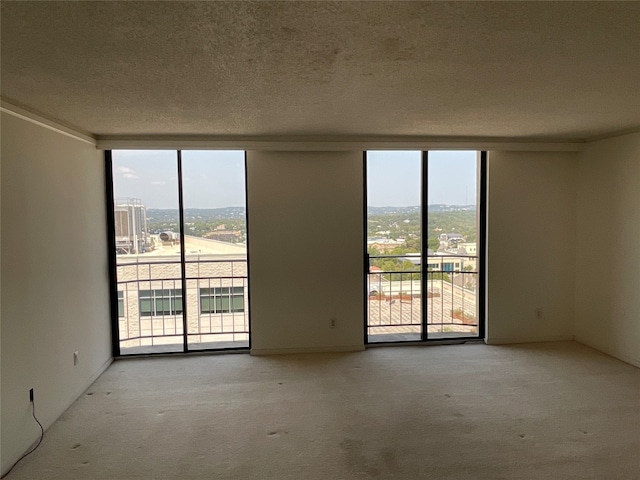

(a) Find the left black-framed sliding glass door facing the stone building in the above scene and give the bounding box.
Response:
[106,150,249,355]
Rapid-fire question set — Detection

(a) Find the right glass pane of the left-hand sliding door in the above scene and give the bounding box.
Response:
[182,151,249,350]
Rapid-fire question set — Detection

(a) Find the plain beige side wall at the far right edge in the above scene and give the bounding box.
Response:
[574,133,640,366]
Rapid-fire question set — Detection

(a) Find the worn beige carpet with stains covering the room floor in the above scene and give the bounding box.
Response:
[8,342,640,480]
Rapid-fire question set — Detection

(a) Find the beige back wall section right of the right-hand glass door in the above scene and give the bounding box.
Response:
[487,152,578,343]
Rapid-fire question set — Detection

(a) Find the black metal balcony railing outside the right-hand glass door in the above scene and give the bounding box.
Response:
[367,255,478,342]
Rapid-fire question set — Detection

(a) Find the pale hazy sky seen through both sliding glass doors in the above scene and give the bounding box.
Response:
[113,150,477,209]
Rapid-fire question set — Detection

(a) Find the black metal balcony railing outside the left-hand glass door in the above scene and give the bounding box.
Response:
[117,257,249,354]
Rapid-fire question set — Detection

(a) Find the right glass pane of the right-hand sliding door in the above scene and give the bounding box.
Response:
[427,151,479,338]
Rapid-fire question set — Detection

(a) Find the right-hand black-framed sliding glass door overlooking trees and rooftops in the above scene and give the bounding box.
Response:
[365,151,485,343]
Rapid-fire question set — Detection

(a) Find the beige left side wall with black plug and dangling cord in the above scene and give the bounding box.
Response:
[1,113,111,472]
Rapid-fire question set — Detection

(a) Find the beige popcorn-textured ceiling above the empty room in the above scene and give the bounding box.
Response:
[1,0,640,139]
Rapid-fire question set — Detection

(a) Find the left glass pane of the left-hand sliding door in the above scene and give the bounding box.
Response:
[112,150,183,355]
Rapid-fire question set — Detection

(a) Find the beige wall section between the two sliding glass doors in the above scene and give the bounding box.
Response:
[247,152,365,353]
